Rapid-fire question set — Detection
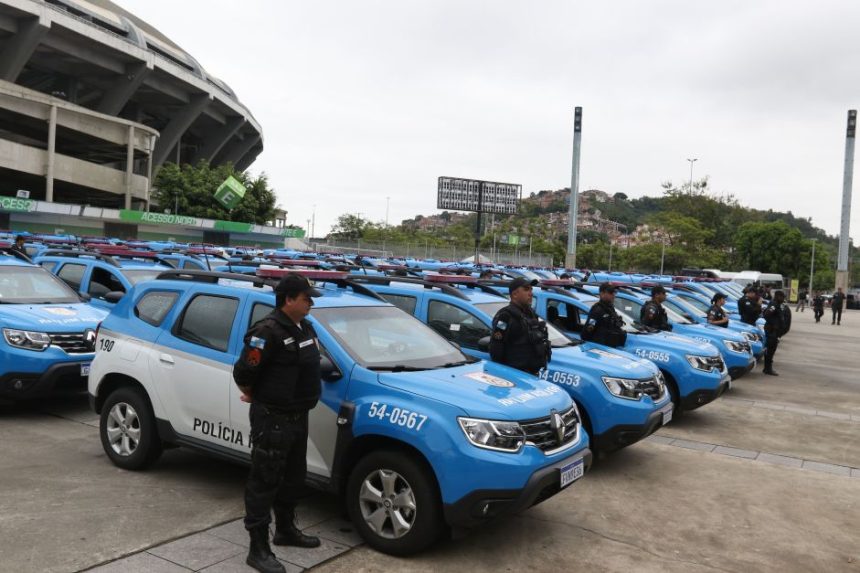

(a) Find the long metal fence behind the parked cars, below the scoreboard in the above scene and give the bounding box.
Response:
[311,240,552,267]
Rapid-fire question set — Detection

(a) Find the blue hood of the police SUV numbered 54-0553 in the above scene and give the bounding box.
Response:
[549,343,658,379]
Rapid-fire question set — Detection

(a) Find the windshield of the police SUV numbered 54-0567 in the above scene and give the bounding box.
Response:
[312,306,474,370]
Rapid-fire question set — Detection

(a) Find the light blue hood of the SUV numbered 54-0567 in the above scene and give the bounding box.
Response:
[379,360,571,420]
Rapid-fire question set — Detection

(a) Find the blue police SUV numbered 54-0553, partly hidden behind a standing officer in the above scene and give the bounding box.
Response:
[354,274,673,452]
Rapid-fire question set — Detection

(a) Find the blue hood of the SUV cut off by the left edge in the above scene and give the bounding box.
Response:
[0,303,108,332]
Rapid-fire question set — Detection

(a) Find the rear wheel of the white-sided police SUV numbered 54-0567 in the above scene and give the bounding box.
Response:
[99,387,163,470]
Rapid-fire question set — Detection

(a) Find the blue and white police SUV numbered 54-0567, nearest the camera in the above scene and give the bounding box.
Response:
[89,269,591,554]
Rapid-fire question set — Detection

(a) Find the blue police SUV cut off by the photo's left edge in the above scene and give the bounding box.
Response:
[0,251,107,400]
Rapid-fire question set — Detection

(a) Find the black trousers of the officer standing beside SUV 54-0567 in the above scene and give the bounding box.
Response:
[245,404,308,529]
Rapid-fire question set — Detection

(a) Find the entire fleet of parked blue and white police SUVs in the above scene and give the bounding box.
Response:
[0,234,776,555]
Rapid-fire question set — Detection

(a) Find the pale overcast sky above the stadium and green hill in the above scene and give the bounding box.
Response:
[118,0,860,237]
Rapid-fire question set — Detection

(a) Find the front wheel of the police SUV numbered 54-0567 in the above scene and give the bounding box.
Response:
[346,450,444,556]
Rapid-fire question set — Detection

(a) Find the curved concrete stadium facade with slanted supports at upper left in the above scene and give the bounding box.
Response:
[0,0,263,209]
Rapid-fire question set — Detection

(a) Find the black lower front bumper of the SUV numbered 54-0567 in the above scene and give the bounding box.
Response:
[443,448,592,528]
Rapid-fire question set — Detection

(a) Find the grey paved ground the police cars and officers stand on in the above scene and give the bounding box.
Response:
[0,312,860,573]
